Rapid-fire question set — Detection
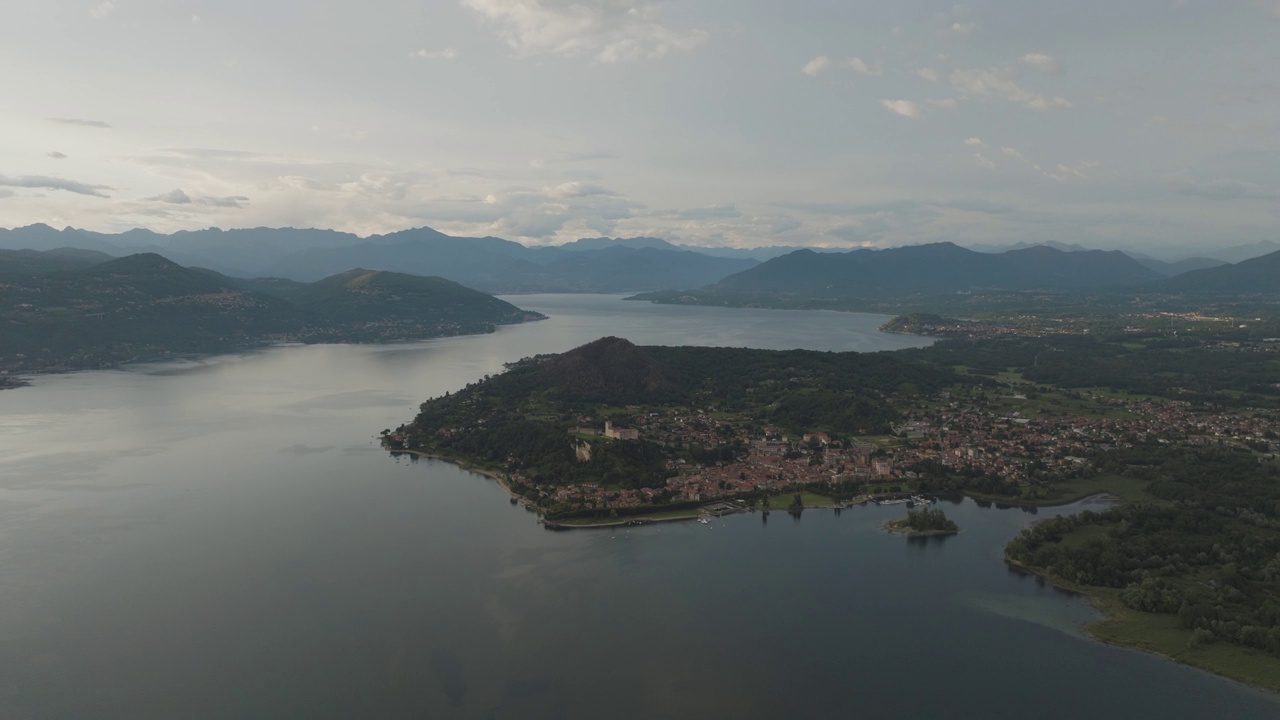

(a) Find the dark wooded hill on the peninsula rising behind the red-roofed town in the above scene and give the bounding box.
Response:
[392,337,956,488]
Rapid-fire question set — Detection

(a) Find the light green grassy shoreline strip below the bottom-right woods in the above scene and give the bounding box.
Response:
[1004,553,1280,694]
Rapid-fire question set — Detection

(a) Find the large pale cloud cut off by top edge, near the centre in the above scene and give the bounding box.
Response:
[461,0,709,63]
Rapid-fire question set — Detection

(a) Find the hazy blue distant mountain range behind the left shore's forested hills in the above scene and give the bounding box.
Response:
[0,224,758,292]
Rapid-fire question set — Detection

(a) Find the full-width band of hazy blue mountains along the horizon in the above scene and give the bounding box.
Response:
[0,224,1280,293]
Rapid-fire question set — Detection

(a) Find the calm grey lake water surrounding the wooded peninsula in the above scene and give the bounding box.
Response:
[0,296,1280,720]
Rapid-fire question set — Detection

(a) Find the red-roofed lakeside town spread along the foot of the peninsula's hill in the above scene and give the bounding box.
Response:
[387,392,1280,512]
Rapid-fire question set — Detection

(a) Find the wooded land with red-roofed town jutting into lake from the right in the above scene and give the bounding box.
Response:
[384,320,1280,691]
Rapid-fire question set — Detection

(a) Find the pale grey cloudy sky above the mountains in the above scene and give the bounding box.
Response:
[0,0,1280,252]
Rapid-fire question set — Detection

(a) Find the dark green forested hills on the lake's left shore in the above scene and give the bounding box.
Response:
[0,252,538,373]
